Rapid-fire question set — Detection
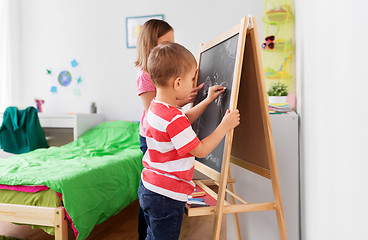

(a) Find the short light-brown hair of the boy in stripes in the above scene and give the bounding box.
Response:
[147,43,197,87]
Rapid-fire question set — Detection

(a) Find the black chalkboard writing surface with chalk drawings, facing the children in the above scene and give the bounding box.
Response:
[192,34,239,172]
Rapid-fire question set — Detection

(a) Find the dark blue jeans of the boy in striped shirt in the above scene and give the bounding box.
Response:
[138,181,185,240]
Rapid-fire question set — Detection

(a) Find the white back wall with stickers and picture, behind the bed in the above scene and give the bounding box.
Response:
[20,0,263,120]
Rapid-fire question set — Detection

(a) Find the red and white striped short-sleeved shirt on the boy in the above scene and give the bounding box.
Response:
[142,99,200,202]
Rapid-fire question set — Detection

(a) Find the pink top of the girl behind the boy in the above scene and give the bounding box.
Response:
[137,69,156,137]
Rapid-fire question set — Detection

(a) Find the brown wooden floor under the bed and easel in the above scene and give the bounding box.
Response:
[0,200,226,240]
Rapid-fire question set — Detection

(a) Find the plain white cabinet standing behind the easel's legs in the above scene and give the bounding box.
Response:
[227,112,300,240]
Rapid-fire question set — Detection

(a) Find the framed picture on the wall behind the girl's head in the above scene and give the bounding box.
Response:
[126,14,164,48]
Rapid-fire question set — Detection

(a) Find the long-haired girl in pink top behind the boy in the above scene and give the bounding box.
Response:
[135,19,203,240]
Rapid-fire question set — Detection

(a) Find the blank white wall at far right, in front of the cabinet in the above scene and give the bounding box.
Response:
[296,0,368,240]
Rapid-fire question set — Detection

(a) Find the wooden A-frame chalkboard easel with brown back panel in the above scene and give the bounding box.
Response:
[186,17,287,240]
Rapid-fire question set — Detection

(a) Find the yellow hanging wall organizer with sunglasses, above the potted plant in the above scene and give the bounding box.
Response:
[261,0,296,97]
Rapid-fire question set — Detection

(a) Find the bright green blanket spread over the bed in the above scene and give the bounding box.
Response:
[0,121,143,240]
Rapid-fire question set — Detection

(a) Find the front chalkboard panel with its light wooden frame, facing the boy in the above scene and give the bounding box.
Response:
[193,19,246,181]
